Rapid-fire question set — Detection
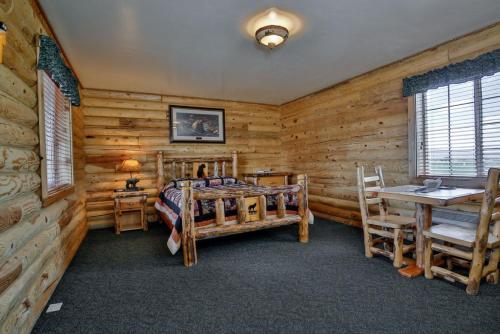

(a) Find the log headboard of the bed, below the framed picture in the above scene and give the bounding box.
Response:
[156,151,238,189]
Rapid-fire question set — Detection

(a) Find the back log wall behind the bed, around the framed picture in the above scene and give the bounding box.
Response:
[82,89,281,228]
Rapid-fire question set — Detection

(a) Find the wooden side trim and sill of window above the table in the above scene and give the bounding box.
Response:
[407,90,486,188]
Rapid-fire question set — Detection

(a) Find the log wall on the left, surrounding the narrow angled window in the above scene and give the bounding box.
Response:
[0,0,87,333]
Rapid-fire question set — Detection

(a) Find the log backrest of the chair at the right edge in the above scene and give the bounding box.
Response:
[476,168,500,242]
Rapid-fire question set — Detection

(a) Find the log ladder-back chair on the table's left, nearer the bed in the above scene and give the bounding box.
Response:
[357,166,416,268]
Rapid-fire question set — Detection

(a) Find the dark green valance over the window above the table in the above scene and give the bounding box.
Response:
[403,49,500,96]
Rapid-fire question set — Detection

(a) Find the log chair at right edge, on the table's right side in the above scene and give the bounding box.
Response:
[424,168,500,295]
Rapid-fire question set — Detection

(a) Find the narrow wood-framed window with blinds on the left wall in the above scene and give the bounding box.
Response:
[39,71,73,205]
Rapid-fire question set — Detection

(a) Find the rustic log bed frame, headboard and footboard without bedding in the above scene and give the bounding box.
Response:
[157,151,309,267]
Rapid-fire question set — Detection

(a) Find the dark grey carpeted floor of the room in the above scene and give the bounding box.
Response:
[34,221,500,334]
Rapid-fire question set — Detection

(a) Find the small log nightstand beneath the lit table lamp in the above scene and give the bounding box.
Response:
[113,191,148,234]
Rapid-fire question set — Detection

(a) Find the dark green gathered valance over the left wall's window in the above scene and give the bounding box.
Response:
[38,35,80,106]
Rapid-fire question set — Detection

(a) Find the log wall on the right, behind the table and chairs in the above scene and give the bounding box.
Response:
[281,24,500,226]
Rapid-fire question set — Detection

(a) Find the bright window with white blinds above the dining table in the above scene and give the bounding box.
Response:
[414,72,500,177]
